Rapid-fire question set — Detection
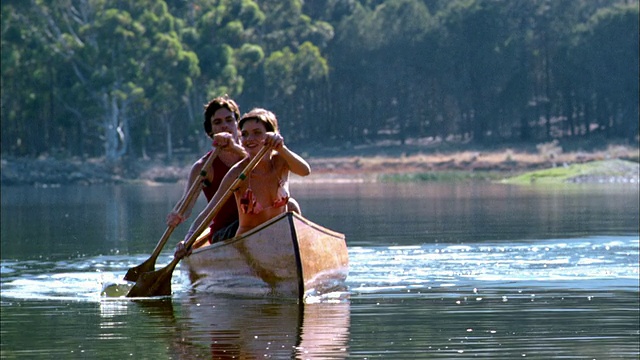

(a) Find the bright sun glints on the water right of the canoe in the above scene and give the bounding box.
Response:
[349,238,639,296]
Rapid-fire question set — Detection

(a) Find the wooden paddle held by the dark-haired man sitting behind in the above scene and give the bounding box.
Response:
[124,148,220,281]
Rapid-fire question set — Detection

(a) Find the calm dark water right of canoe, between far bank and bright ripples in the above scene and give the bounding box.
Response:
[295,183,639,246]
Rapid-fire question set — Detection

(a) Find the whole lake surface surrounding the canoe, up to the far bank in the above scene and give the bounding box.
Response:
[0,182,640,359]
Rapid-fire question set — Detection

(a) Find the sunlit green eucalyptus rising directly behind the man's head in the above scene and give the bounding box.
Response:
[168,0,265,150]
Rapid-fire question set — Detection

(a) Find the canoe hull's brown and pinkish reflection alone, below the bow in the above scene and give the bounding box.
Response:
[173,296,350,359]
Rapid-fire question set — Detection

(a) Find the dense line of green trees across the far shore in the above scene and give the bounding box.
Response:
[1,0,639,161]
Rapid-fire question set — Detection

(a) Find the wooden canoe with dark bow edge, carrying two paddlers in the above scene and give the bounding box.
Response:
[182,212,348,298]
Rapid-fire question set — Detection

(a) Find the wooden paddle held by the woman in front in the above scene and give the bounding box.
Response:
[127,146,271,297]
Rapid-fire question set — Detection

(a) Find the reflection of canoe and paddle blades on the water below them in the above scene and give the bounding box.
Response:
[95,294,350,359]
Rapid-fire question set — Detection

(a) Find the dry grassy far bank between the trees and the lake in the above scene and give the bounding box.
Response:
[1,142,639,186]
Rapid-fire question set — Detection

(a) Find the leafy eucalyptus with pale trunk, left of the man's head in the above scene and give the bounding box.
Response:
[83,0,199,159]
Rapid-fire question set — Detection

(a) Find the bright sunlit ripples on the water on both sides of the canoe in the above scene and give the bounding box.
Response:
[1,237,639,301]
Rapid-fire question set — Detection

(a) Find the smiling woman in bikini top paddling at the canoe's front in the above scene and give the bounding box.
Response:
[175,109,311,258]
